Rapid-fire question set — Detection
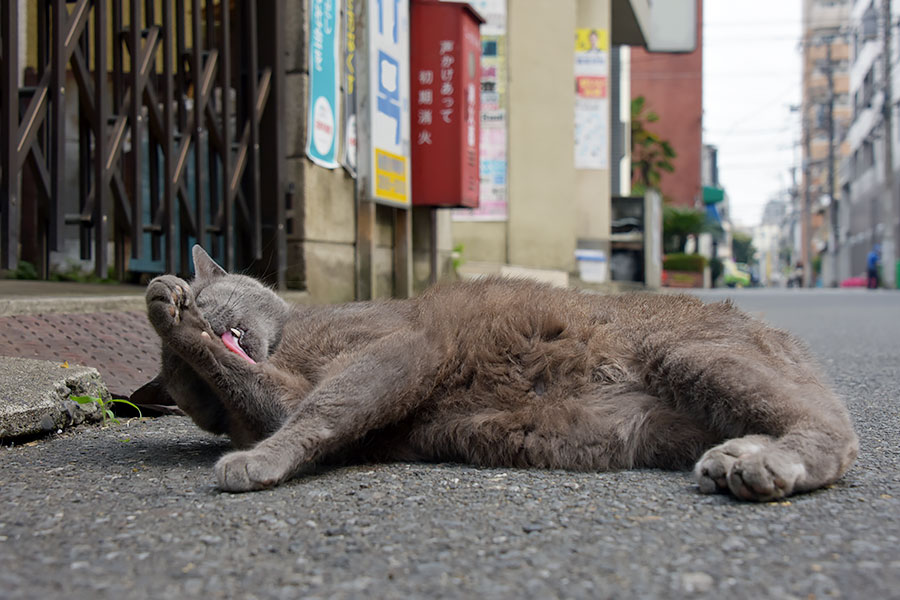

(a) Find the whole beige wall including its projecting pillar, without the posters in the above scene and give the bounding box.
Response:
[452,0,611,271]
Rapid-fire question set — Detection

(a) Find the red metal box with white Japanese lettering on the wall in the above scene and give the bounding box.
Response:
[409,0,484,208]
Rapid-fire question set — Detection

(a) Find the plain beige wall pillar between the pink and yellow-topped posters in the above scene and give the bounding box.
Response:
[507,0,577,271]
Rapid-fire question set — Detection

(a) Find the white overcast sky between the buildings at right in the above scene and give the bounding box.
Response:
[703,0,802,226]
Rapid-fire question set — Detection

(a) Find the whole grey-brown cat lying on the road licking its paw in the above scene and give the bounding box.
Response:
[139,246,857,500]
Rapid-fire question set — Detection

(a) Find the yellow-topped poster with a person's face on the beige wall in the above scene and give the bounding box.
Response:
[575,29,609,170]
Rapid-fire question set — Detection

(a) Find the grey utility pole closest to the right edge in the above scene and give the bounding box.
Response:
[881,0,897,289]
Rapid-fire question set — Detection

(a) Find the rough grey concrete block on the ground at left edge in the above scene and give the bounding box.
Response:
[0,356,110,440]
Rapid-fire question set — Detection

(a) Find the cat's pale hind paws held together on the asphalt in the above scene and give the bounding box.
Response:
[694,436,806,502]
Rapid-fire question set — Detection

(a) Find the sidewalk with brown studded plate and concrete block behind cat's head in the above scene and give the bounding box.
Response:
[0,279,307,440]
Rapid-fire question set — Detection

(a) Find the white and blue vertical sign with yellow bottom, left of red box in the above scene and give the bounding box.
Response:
[366,0,411,207]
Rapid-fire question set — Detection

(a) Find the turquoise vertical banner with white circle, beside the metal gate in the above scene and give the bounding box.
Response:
[306,0,340,169]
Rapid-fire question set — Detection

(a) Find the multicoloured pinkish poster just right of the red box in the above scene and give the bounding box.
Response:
[453,0,508,221]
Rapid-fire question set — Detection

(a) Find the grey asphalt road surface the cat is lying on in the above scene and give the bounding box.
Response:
[0,290,900,600]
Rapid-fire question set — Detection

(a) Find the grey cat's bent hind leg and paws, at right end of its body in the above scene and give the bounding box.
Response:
[647,326,858,501]
